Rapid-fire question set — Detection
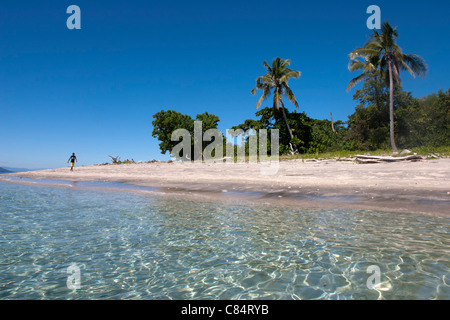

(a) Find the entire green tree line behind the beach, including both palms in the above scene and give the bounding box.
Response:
[152,32,442,159]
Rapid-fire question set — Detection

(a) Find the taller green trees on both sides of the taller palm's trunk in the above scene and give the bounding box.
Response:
[342,76,450,150]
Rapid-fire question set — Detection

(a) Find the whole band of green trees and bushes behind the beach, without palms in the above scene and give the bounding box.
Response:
[153,82,450,159]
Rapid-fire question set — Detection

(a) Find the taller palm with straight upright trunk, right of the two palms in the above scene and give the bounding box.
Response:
[349,21,427,150]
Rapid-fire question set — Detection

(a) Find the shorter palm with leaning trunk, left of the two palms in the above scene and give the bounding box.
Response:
[251,57,301,153]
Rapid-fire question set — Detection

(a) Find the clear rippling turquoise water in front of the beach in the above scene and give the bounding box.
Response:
[0,182,450,299]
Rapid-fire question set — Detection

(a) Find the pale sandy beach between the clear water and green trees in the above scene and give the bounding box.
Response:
[0,159,450,216]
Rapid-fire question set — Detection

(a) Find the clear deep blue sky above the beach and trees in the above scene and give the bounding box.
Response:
[0,0,450,168]
